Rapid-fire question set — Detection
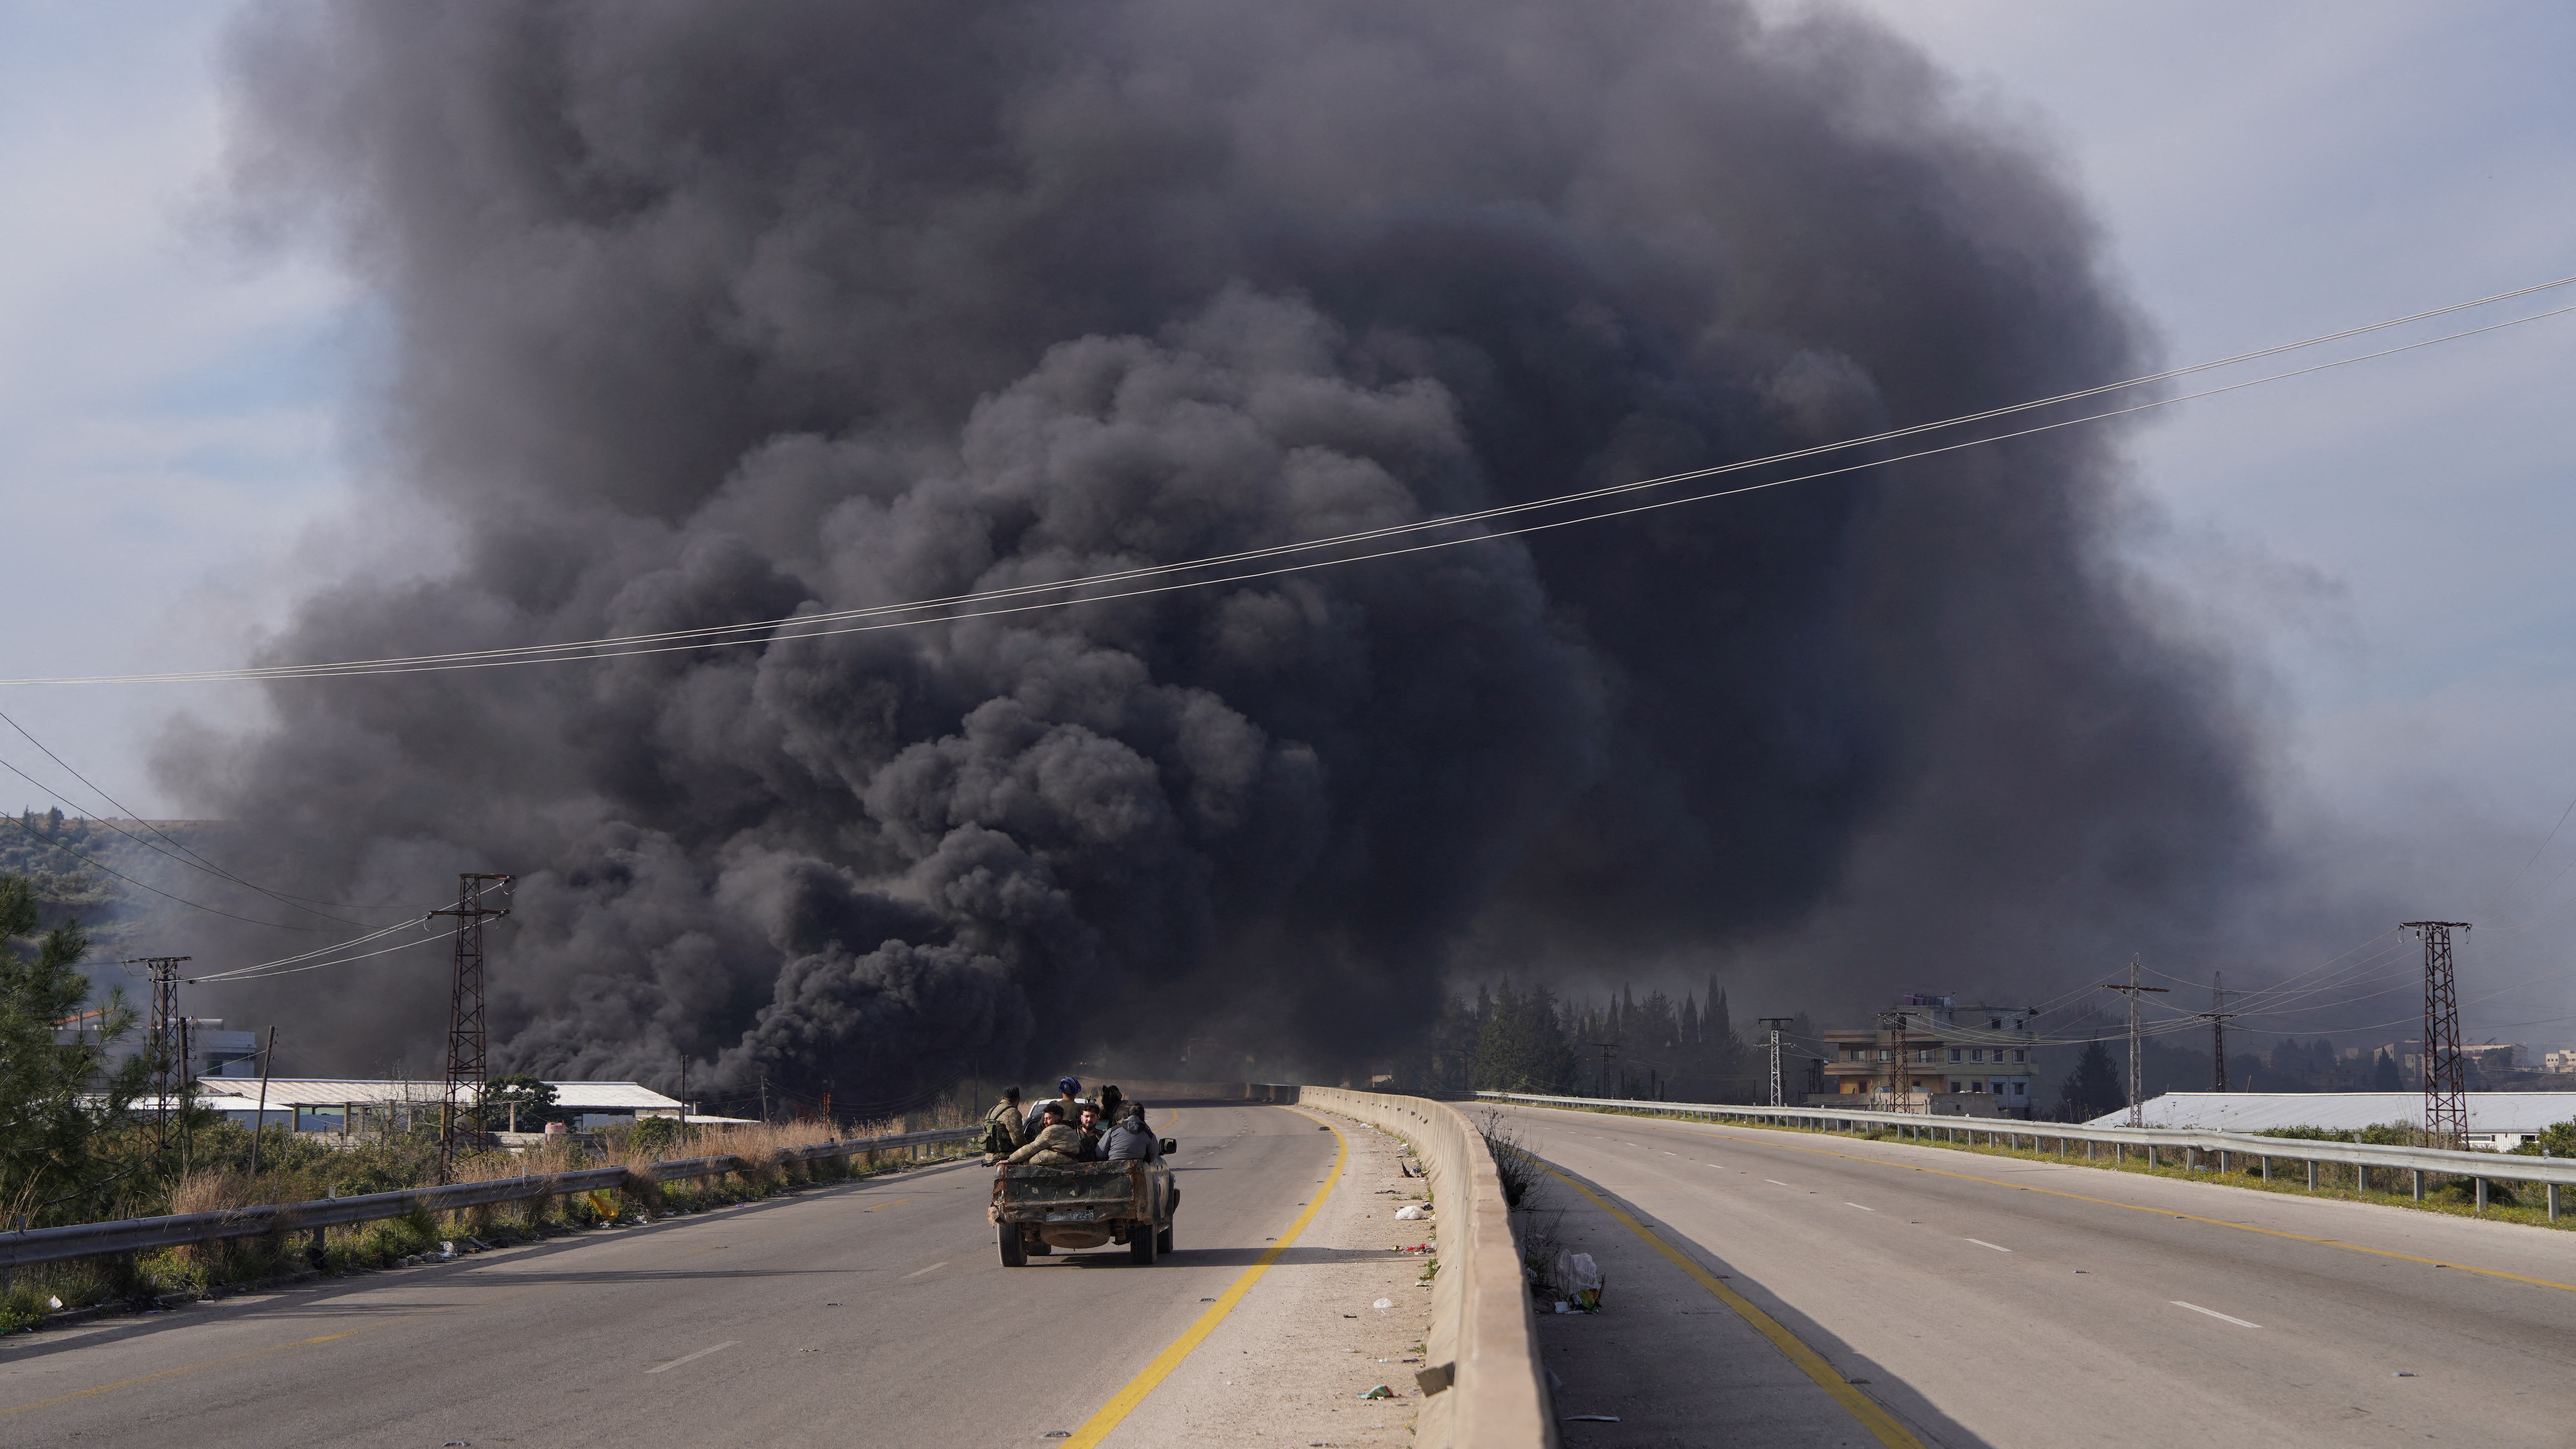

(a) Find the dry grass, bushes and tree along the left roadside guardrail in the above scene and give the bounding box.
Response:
[0,874,984,1333]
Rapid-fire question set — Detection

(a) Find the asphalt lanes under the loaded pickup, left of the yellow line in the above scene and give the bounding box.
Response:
[0,1106,1340,1449]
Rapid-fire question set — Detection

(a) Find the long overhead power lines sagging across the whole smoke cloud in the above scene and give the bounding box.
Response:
[0,279,2576,686]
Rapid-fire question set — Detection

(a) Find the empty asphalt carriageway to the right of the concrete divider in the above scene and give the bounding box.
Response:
[1507,1093,2576,1449]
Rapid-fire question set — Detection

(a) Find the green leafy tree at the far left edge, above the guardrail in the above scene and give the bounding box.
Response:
[0,876,152,1227]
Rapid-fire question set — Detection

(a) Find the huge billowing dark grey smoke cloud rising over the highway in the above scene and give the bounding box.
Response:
[165,0,2256,1096]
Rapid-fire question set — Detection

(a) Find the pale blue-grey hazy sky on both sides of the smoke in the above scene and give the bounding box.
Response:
[0,0,2576,1042]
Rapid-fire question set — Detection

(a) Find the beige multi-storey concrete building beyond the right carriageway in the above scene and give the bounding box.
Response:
[1808,995,2035,1116]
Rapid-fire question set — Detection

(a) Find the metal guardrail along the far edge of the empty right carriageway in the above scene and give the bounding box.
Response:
[1476,1091,2576,1222]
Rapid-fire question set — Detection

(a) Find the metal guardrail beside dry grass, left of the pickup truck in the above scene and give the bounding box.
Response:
[0,1127,984,1269]
